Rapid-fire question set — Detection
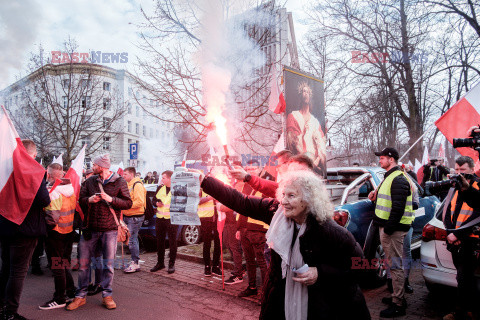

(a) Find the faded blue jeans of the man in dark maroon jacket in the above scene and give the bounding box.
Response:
[76,230,117,298]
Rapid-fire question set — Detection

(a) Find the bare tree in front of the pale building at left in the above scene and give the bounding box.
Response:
[9,40,125,165]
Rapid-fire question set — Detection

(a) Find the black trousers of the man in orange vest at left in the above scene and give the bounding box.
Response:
[45,230,75,302]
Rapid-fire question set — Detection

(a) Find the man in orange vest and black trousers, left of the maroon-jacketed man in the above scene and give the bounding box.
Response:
[39,163,77,310]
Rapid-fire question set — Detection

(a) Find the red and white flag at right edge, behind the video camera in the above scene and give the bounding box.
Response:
[435,82,480,159]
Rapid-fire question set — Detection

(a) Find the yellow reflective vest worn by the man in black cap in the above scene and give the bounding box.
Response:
[375,170,415,226]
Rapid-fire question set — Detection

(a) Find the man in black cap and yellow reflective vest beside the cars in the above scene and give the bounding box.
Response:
[368,148,415,318]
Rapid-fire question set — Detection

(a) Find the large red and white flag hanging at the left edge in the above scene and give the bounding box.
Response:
[0,106,45,225]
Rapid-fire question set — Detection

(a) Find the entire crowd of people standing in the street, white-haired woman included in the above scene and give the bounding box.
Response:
[0,126,480,319]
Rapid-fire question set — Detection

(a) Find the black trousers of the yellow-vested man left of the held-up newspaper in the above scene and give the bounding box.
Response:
[155,218,178,266]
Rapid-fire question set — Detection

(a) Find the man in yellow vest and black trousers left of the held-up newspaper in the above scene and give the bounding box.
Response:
[150,170,178,273]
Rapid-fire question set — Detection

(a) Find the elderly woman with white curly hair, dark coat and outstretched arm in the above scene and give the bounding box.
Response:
[197,171,370,320]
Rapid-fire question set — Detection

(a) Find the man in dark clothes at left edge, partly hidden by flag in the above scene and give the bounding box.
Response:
[0,140,50,319]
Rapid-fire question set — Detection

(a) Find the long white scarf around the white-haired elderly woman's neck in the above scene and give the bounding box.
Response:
[266,206,308,320]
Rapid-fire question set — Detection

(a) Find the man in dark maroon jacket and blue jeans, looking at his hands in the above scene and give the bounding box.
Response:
[67,154,132,310]
